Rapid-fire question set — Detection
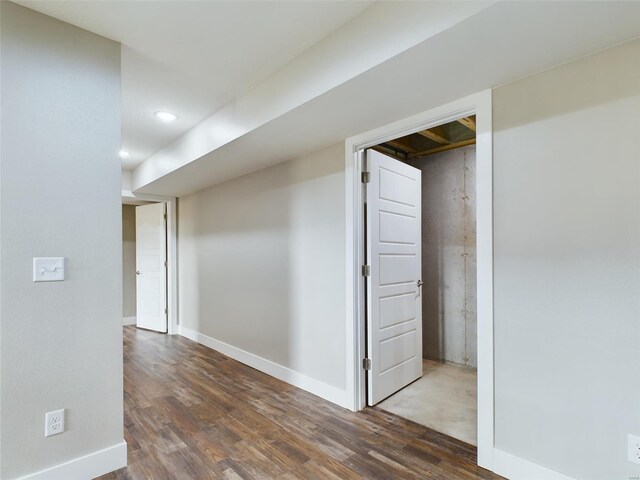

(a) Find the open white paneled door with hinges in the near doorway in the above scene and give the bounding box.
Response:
[366,150,422,405]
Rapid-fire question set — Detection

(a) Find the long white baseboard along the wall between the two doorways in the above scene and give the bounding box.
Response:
[178,327,349,408]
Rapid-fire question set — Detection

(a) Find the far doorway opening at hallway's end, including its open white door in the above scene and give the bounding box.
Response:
[122,200,172,333]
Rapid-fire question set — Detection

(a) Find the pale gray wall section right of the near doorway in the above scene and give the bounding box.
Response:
[493,40,640,480]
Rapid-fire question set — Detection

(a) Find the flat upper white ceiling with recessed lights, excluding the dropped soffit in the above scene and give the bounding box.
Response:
[18,0,372,169]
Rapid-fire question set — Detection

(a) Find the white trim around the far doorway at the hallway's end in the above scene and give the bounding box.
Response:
[122,191,179,335]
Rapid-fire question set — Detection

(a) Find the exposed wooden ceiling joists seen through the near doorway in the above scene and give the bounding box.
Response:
[373,115,476,161]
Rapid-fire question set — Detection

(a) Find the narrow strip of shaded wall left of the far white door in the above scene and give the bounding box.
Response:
[122,205,136,317]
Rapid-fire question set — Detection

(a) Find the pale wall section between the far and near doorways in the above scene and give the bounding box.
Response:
[178,145,346,398]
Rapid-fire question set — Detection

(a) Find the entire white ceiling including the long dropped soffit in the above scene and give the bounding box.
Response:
[18,0,640,195]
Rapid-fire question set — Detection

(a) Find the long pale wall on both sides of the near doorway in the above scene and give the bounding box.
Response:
[179,41,640,479]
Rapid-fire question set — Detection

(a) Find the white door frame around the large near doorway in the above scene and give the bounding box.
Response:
[345,90,495,470]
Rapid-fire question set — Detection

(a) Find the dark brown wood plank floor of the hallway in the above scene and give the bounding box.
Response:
[100,327,502,480]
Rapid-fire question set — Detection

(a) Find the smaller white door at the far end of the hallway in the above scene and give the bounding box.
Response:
[136,203,167,332]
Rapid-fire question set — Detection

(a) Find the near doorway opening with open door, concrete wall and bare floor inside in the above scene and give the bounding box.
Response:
[364,115,477,446]
